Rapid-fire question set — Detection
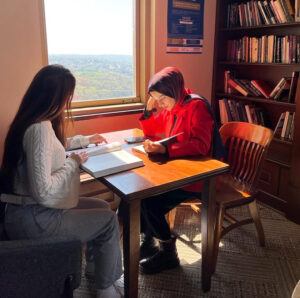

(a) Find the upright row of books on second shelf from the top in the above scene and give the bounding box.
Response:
[227,35,300,63]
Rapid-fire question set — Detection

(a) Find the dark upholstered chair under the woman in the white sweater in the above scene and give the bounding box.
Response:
[0,202,82,298]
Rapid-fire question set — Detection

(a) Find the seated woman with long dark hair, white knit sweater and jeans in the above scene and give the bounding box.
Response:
[0,65,122,297]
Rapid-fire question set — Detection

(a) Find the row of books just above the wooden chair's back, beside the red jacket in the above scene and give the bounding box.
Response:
[218,98,266,126]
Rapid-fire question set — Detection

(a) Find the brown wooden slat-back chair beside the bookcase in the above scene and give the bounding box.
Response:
[169,122,273,268]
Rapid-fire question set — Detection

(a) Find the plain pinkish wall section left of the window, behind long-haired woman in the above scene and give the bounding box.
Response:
[0,0,42,160]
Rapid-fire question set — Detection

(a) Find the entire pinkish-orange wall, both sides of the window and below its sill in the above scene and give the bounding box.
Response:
[0,0,216,160]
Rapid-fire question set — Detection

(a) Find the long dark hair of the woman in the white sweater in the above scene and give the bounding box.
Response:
[0,65,76,193]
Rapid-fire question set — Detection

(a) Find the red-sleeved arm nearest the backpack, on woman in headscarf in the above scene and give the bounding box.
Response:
[167,100,214,158]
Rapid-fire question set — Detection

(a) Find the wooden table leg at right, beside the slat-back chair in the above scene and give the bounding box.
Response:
[201,178,215,292]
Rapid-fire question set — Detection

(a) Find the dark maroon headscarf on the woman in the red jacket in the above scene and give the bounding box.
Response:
[148,66,186,101]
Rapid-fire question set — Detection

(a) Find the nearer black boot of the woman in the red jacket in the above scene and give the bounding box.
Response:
[140,237,180,274]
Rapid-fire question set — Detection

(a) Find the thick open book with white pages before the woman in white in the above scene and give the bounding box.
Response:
[81,150,144,178]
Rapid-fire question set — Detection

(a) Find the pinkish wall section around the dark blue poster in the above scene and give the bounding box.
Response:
[155,0,216,100]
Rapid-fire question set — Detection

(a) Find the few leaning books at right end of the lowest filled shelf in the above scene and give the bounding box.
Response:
[274,111,295,141]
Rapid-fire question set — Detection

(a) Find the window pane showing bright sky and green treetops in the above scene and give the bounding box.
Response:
[44,0,139,107]
